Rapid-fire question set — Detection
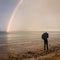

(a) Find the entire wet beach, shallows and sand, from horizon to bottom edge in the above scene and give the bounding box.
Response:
[0,32,60,60]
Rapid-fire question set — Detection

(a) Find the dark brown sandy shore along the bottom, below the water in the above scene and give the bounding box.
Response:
[0,44,60,60]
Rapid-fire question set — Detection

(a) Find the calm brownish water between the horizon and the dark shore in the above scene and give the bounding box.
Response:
[0,31,60,52]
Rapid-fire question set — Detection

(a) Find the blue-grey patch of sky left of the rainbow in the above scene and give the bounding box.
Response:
[0,0,18,31]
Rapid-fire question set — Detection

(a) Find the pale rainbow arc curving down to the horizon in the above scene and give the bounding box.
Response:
[6,0,23,32]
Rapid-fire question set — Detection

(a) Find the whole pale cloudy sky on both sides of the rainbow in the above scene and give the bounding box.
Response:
[0,0,60,31]
